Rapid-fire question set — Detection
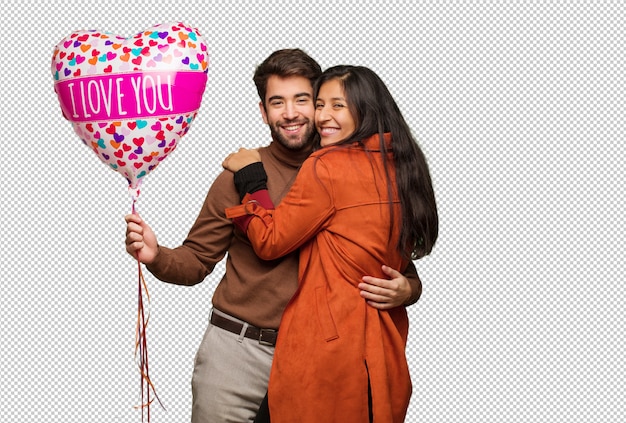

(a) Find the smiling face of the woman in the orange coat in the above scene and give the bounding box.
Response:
[315,79,356,147]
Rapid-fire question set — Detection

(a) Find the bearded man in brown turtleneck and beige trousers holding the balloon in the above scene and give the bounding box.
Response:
[126,49,421,423]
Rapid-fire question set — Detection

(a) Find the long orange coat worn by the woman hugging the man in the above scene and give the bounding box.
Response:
[224,134,411,423]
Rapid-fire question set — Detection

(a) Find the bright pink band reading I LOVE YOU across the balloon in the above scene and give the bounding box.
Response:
[55,71,207,122]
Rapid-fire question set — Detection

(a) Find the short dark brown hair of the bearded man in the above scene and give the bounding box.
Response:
[253,48,322,107]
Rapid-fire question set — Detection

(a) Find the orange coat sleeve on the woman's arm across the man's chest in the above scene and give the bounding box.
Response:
[226,157,335,260]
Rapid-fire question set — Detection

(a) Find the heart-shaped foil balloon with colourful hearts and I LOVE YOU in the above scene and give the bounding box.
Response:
[52,22,209,199]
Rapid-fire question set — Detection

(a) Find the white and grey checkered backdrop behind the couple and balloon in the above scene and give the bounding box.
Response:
[0,0,626,423]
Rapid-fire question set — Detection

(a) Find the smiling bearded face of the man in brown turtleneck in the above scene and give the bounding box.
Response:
[260,75,315,150]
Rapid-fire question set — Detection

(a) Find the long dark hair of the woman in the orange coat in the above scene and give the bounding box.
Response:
[313,65,439,259]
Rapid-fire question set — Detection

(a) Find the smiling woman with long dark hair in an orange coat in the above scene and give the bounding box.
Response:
[224,66,438,423]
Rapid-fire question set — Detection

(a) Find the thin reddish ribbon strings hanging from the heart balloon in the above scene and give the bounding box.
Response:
[132,198,165,423]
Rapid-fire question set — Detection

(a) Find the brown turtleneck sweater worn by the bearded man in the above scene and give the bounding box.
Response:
[147,142,309,329]
